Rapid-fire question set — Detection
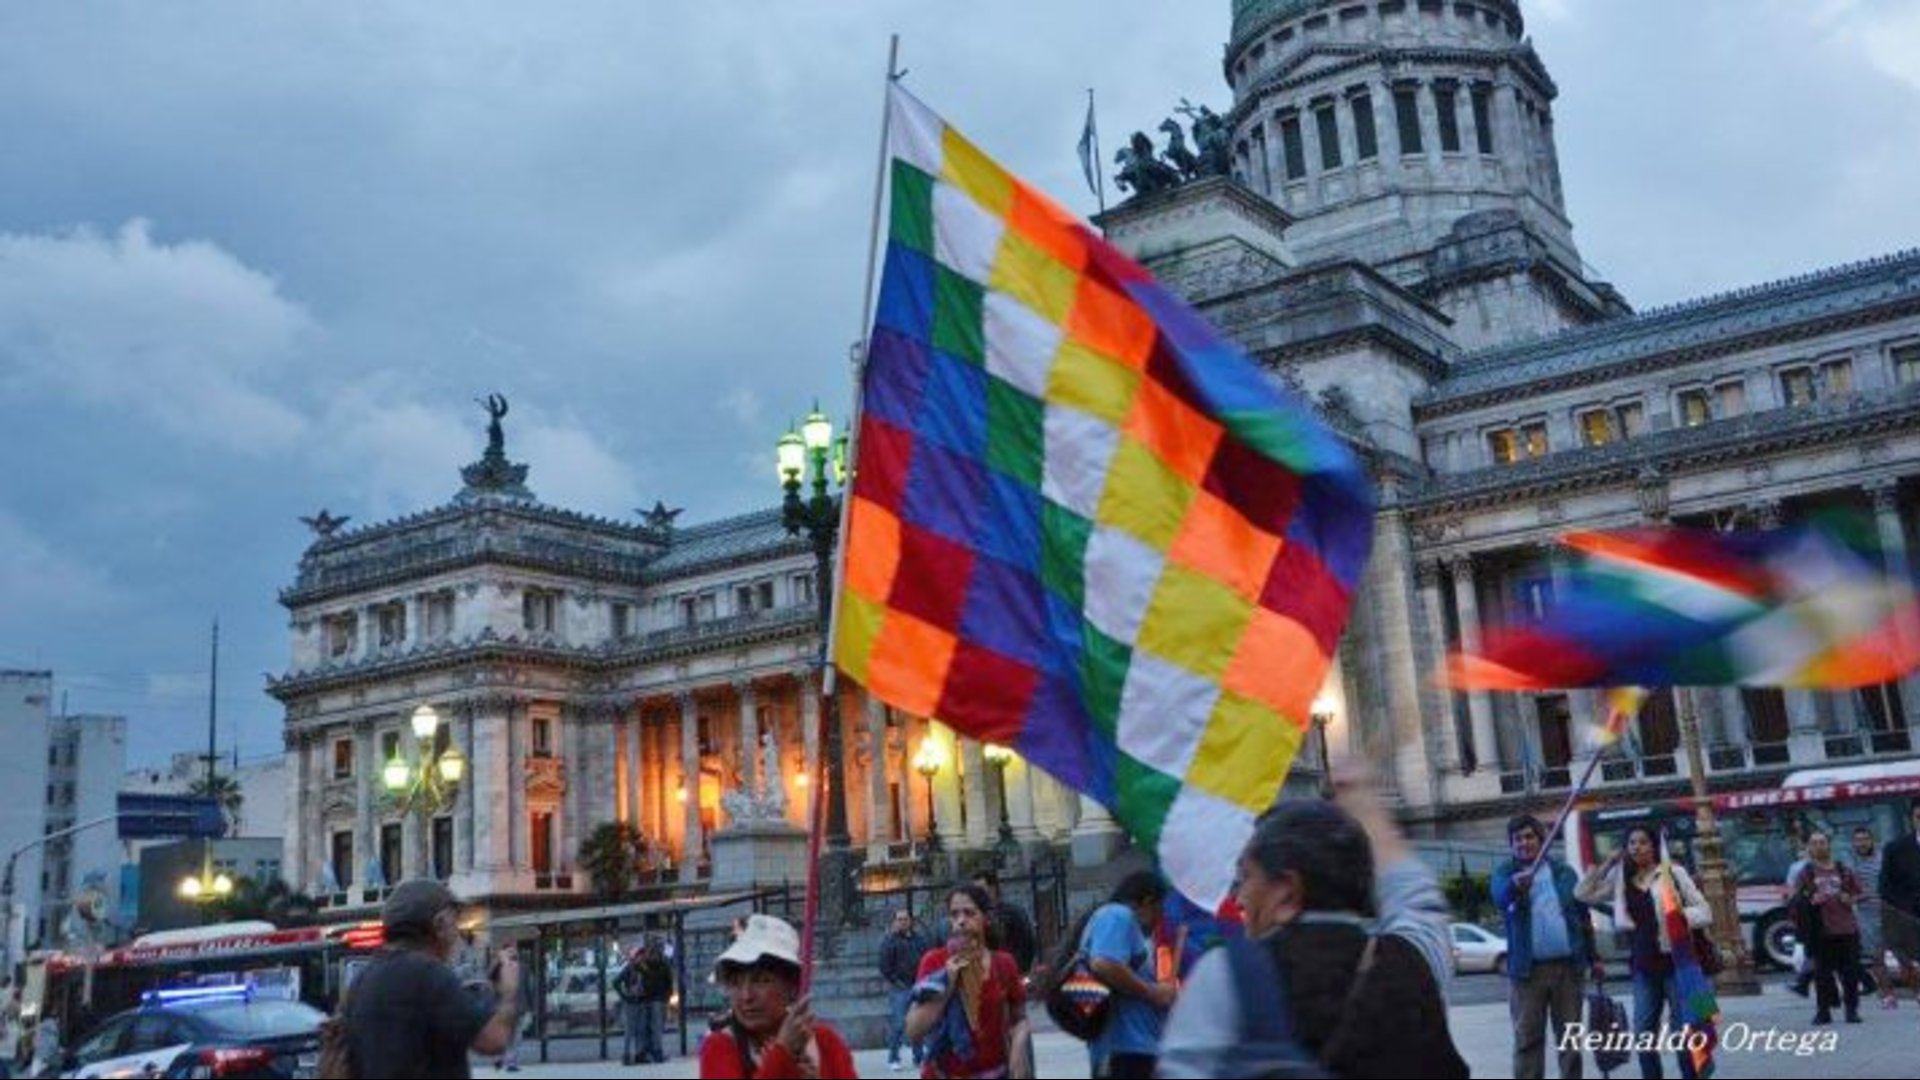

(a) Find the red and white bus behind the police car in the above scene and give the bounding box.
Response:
[21,922,386,1045]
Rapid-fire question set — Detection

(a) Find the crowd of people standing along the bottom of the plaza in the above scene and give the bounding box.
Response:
[288,771,1920,1080]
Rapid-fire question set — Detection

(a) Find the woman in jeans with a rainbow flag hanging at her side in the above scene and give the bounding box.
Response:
[1574,824,1716,1080]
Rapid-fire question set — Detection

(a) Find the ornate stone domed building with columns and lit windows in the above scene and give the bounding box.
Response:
[269,0,1920,907]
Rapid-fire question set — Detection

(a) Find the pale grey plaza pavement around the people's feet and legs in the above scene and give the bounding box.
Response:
[474,988,1920,1080]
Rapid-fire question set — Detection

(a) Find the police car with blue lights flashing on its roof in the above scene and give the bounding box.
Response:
[60,988,326,1080]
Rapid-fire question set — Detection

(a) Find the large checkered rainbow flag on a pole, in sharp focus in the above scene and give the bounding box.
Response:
[833,86,1373,907]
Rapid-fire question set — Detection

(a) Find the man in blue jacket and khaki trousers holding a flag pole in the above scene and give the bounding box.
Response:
[1494,815,1603,1080]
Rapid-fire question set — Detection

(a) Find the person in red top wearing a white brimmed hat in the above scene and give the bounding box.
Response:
[701,915,860,1080]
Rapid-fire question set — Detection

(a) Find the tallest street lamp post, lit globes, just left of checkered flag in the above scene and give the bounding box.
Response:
[774,404,860,922]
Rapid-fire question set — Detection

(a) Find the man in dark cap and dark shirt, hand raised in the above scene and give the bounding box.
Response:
[342,880,520,1078]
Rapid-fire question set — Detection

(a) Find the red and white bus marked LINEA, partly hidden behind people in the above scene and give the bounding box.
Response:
[1567,759,1920,969]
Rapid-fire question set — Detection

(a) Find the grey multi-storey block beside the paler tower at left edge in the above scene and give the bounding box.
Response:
[40,713,127,942]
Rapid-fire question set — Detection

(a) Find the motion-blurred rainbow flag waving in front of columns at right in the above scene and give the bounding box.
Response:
[1450,519,1920,690]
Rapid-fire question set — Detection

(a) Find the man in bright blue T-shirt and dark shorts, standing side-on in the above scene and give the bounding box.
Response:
[1081,871,1175,1080]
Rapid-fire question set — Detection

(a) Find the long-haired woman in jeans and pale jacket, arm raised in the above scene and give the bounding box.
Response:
[1574,824,1713,1080]
